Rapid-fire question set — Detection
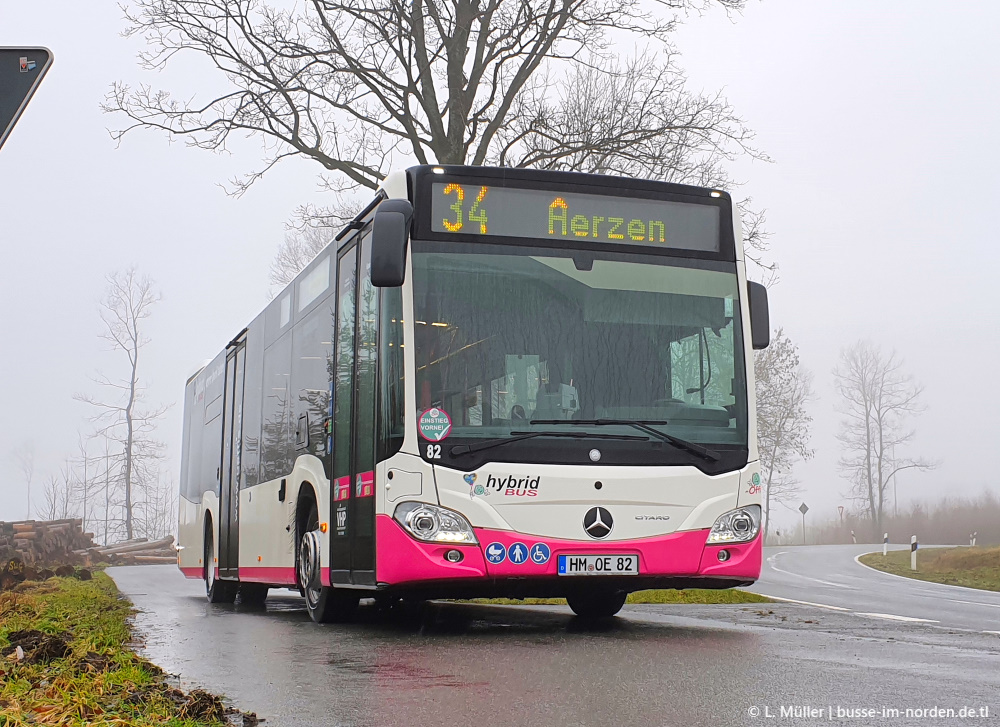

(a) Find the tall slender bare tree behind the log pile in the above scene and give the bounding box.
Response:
[75,268,166,538]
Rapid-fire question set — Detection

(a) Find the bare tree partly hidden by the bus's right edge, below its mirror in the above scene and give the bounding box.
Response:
[753,328,813,534]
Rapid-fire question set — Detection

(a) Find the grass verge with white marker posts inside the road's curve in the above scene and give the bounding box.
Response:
[859,547,1000,591]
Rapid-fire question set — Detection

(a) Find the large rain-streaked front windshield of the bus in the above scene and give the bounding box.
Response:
[411,241,747,464]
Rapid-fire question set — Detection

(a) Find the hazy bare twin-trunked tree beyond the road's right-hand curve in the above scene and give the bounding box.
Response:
[833,341,934,533]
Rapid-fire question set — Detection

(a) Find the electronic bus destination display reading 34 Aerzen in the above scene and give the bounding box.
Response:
[431,182,720,252]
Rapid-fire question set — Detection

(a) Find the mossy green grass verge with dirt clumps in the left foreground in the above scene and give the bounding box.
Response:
[0,573,236,727]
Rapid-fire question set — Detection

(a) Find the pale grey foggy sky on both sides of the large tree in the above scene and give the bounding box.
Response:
[0,0,1000,540]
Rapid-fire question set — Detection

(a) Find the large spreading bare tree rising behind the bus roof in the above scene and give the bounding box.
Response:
[103,0,764,278]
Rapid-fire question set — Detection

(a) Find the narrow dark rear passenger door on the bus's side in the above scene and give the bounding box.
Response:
[218,332,246,579]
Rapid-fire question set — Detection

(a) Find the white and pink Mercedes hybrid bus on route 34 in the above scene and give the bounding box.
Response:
[178,165,769,622]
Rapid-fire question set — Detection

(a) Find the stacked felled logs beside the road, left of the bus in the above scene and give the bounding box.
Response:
[0,518,177,566]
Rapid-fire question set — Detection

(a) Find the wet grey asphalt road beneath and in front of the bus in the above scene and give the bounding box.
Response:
[109,548,1000,727]
